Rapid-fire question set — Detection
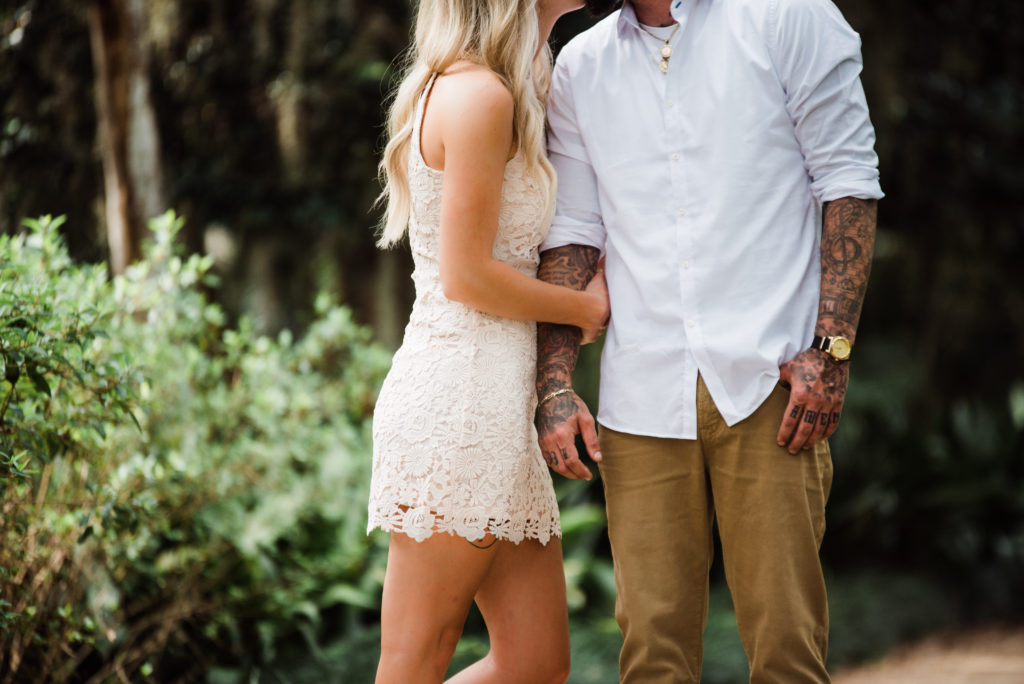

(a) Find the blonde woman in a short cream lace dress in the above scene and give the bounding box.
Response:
[369,0,608,684]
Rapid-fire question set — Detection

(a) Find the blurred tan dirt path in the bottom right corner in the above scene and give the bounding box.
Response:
[833,628,1024,684]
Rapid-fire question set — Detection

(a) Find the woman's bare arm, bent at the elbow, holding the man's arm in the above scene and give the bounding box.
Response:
[423,69,608,329]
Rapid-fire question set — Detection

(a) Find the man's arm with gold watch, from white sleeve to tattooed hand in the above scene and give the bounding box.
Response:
[769,0,883,454]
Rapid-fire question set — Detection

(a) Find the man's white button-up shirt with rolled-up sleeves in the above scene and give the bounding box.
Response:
[542,0,882,438]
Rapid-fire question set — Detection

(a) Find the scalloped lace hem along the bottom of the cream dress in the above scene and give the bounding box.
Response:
[367,506,562,545]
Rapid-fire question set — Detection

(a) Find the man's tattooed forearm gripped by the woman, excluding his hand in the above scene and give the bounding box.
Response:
[537,245,601,396]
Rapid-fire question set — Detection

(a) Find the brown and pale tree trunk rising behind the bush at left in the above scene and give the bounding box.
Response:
[89,0,167,273]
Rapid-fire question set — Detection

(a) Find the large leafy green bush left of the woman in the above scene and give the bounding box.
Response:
[0,214,389,681]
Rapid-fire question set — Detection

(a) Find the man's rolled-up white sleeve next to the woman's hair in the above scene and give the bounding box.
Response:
[541,56,605,252]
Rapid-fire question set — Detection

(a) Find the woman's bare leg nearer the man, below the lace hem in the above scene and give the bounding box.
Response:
[449,538,569,684]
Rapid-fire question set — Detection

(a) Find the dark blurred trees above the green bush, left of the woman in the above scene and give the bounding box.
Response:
[0,0,410,345]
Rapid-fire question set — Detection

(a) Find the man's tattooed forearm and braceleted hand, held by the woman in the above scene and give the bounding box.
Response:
[537,245,601,480]
